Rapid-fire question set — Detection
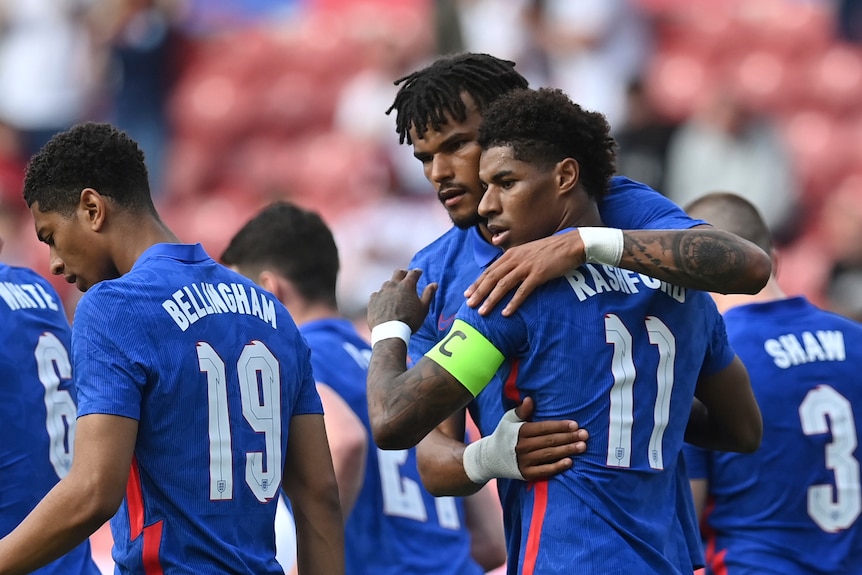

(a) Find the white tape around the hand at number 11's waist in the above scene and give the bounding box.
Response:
[463,409,524,483]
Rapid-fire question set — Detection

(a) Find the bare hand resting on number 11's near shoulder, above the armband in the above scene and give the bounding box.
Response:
[464,230,587,315]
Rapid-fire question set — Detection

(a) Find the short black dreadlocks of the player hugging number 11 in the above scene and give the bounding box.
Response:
[386,52,528,144]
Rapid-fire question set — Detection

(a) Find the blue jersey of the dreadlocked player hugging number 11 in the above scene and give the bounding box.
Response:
[408,176,706,569]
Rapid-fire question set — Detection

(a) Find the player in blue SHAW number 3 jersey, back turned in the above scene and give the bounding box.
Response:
[685,192,862,575]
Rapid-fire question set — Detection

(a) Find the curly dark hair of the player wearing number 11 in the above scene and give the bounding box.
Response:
[478,88,616,201]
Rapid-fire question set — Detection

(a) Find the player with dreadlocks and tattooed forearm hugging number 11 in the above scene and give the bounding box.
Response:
[389,53,771,563]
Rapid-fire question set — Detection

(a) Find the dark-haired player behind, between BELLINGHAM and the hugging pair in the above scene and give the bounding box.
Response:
[221,202,506,575]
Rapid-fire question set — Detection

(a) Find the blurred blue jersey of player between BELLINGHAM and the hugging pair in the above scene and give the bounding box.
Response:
[300,319,484,575]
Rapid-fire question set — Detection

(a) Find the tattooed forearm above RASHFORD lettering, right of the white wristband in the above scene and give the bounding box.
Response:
[619,227,772,294]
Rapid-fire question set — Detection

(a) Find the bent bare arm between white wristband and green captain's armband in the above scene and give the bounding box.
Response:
[368,344,472,449]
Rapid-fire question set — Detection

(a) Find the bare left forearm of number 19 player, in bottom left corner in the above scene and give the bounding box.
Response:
[0,476,116,575]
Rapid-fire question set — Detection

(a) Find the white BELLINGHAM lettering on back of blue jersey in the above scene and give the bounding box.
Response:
[162,282,277,331]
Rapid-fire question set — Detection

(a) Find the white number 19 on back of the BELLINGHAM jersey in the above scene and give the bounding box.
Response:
[197,341,282,503]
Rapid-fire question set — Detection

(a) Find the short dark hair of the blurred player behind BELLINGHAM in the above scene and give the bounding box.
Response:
[221,201,339,306]
